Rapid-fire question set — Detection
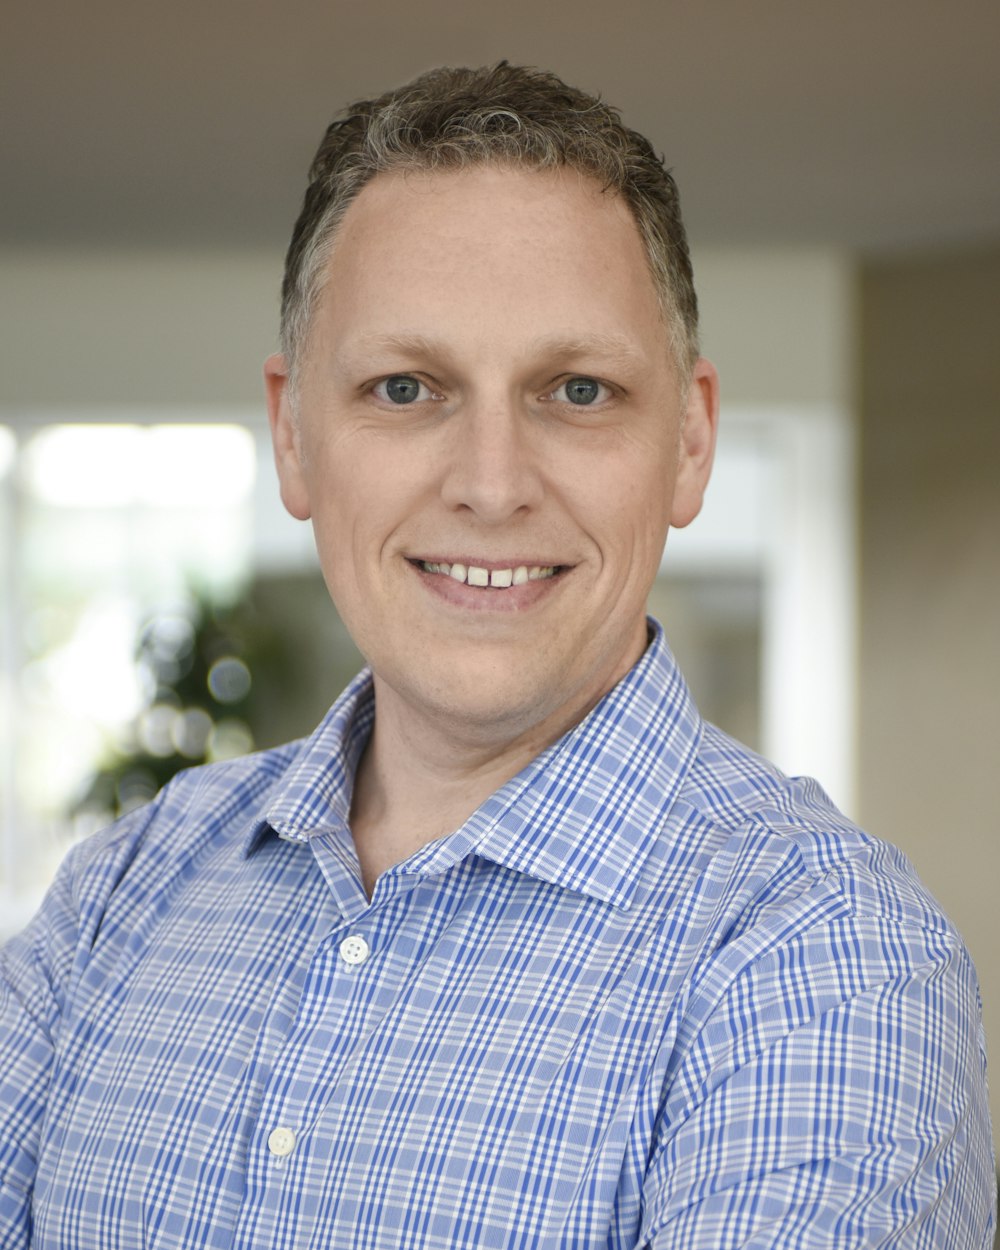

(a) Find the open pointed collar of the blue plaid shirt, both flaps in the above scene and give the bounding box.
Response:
[248,618,701,908]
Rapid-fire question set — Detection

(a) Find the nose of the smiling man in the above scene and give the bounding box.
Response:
[441,398,543,525]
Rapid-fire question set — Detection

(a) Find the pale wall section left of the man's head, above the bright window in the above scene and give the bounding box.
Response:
[0,250,281,410]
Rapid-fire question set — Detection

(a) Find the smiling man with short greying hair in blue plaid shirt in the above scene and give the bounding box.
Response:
[0,65,993,1250]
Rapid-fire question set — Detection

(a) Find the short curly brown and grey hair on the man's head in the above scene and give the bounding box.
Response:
[281,63,698,383]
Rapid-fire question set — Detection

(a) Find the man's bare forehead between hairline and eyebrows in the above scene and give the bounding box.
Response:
[310,166,665,357]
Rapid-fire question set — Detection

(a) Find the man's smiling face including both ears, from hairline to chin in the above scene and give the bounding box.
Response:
[266,168,716,745]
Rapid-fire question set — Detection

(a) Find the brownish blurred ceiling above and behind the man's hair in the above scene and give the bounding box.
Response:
[0,0,1000,253]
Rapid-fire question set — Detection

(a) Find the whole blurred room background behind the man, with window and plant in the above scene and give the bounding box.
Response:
[0,0,1000,1150]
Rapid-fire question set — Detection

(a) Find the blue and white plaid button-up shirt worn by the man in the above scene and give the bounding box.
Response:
[0,629,994,1250]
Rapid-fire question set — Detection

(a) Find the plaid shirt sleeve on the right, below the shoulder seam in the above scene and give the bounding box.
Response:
[641,920,995,1250]
